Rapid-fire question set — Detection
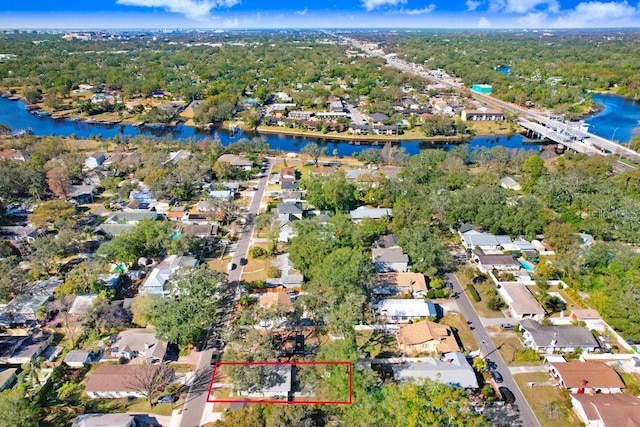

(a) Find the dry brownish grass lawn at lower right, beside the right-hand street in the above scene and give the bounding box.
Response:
[513,372,580,427]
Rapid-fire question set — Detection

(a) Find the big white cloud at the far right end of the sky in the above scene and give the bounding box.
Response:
[555,1,640,28]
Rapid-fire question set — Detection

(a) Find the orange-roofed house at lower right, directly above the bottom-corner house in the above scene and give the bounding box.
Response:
[550,361,624,394]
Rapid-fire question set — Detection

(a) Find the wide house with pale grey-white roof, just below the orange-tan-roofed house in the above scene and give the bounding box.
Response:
[392,352,478,389]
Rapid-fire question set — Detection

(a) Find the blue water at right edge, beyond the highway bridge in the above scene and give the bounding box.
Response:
[585,94,640,143]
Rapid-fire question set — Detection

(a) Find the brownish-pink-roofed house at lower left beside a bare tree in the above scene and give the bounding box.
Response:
[84,364,171,399]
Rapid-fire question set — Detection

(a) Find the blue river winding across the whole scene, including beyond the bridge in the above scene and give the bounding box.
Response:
[0,94,640,156]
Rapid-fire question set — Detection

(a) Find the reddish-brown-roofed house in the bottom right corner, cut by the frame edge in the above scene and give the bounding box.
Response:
[571,394,640,427]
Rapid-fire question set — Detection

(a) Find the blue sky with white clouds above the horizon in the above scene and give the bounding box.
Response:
[0,0,640,29]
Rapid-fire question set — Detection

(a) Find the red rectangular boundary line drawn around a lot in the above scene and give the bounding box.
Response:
[207,362,353,405]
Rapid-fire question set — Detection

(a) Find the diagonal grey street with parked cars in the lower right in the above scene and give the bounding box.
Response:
[446,273,540,427]
